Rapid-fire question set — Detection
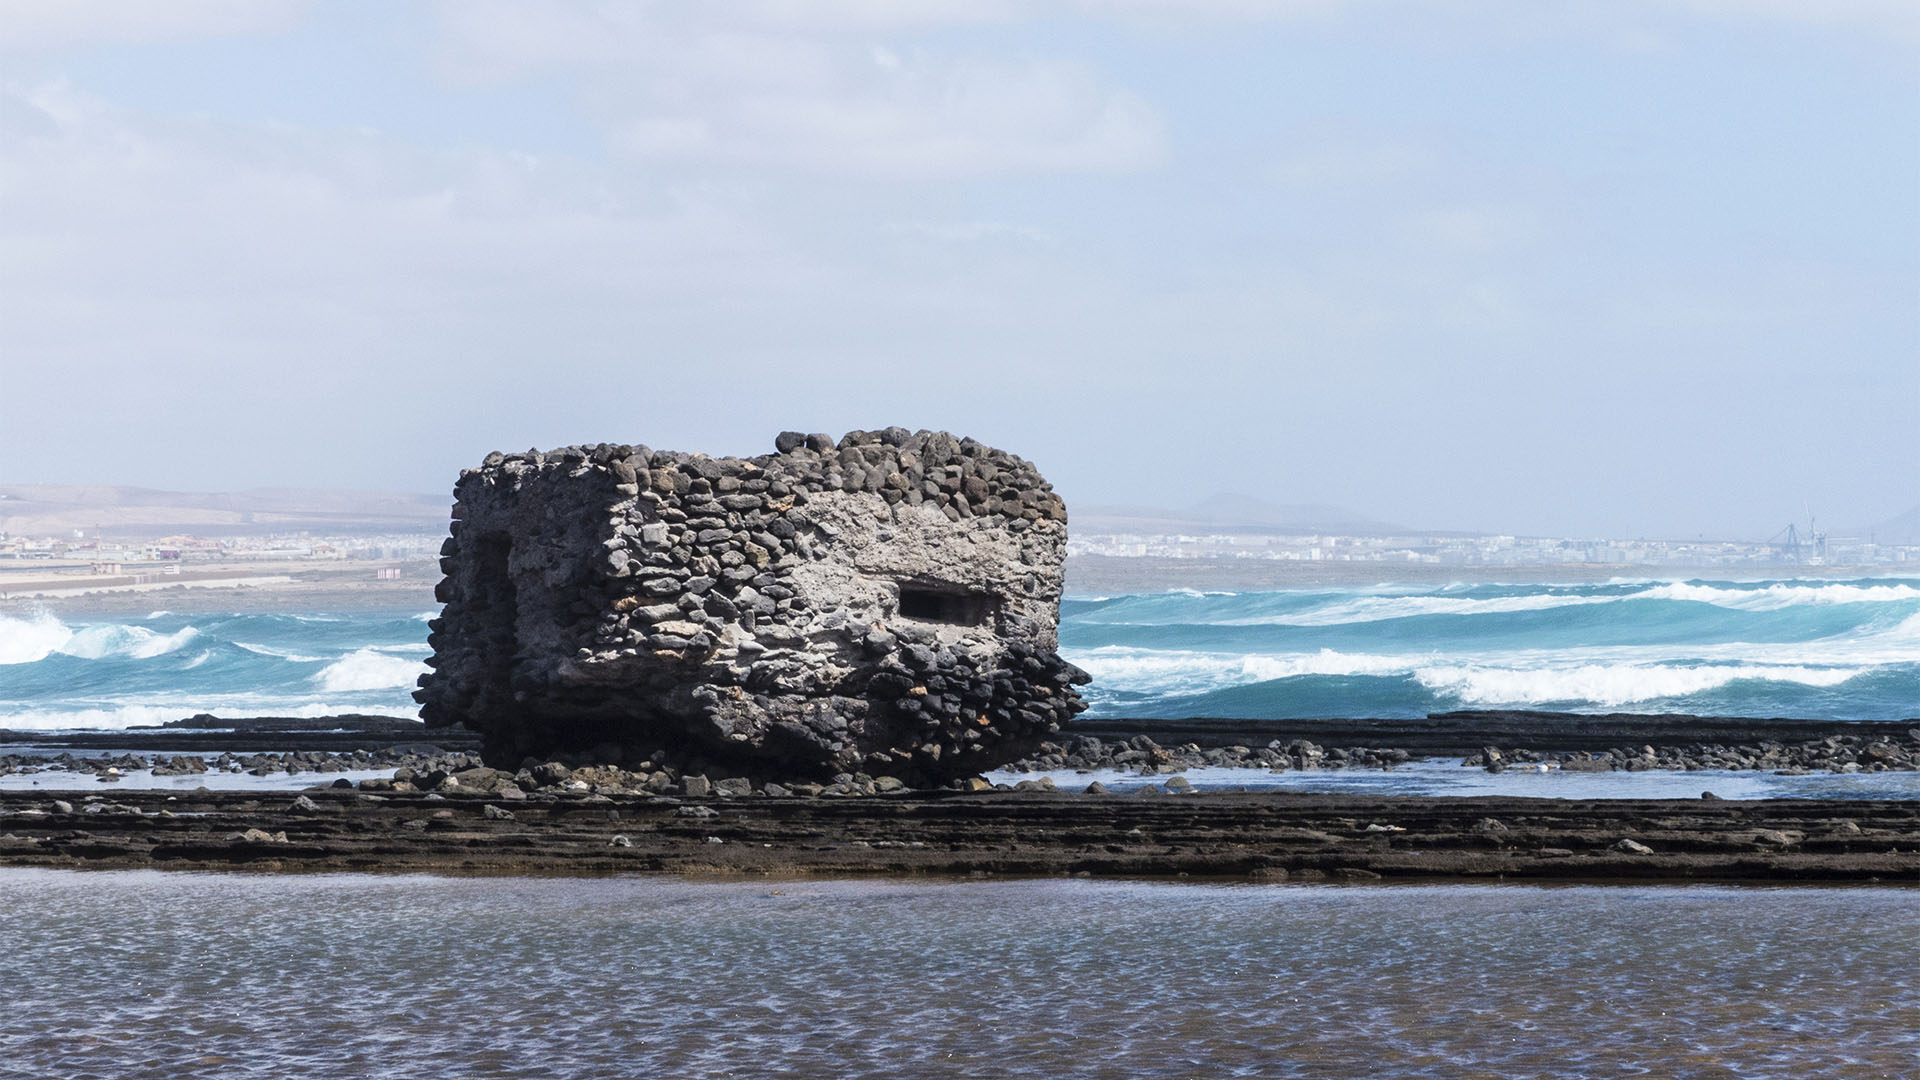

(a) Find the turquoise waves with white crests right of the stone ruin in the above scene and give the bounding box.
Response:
[1060,578,1920,721]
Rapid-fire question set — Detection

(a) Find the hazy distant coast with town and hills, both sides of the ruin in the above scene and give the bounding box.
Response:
[0,484,1920,601]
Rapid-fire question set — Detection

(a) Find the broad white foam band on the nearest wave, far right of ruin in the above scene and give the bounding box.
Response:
[1413,663,1860,705]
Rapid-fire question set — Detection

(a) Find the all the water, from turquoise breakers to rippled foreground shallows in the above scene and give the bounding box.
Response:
[0,577,1920,1080]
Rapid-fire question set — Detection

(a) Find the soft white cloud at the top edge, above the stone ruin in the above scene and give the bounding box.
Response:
[428,4,1165,179]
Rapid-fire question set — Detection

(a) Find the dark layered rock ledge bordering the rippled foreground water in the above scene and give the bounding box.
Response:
[0,790,1920,886]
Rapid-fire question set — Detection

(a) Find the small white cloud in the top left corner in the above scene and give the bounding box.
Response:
[0,0,307,52]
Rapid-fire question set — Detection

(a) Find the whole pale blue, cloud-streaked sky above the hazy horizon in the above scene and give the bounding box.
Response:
[0,0,1920,538]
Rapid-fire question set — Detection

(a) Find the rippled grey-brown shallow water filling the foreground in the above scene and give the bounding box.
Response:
[0,871,1920,1078]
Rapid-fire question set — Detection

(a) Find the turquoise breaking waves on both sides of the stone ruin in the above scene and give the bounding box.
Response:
[0,578,1920,730]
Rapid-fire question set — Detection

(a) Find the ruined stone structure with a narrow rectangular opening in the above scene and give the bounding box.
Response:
[415,429,1087,784]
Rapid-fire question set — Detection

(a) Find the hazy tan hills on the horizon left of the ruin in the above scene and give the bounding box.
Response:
[0,484,451,536]
